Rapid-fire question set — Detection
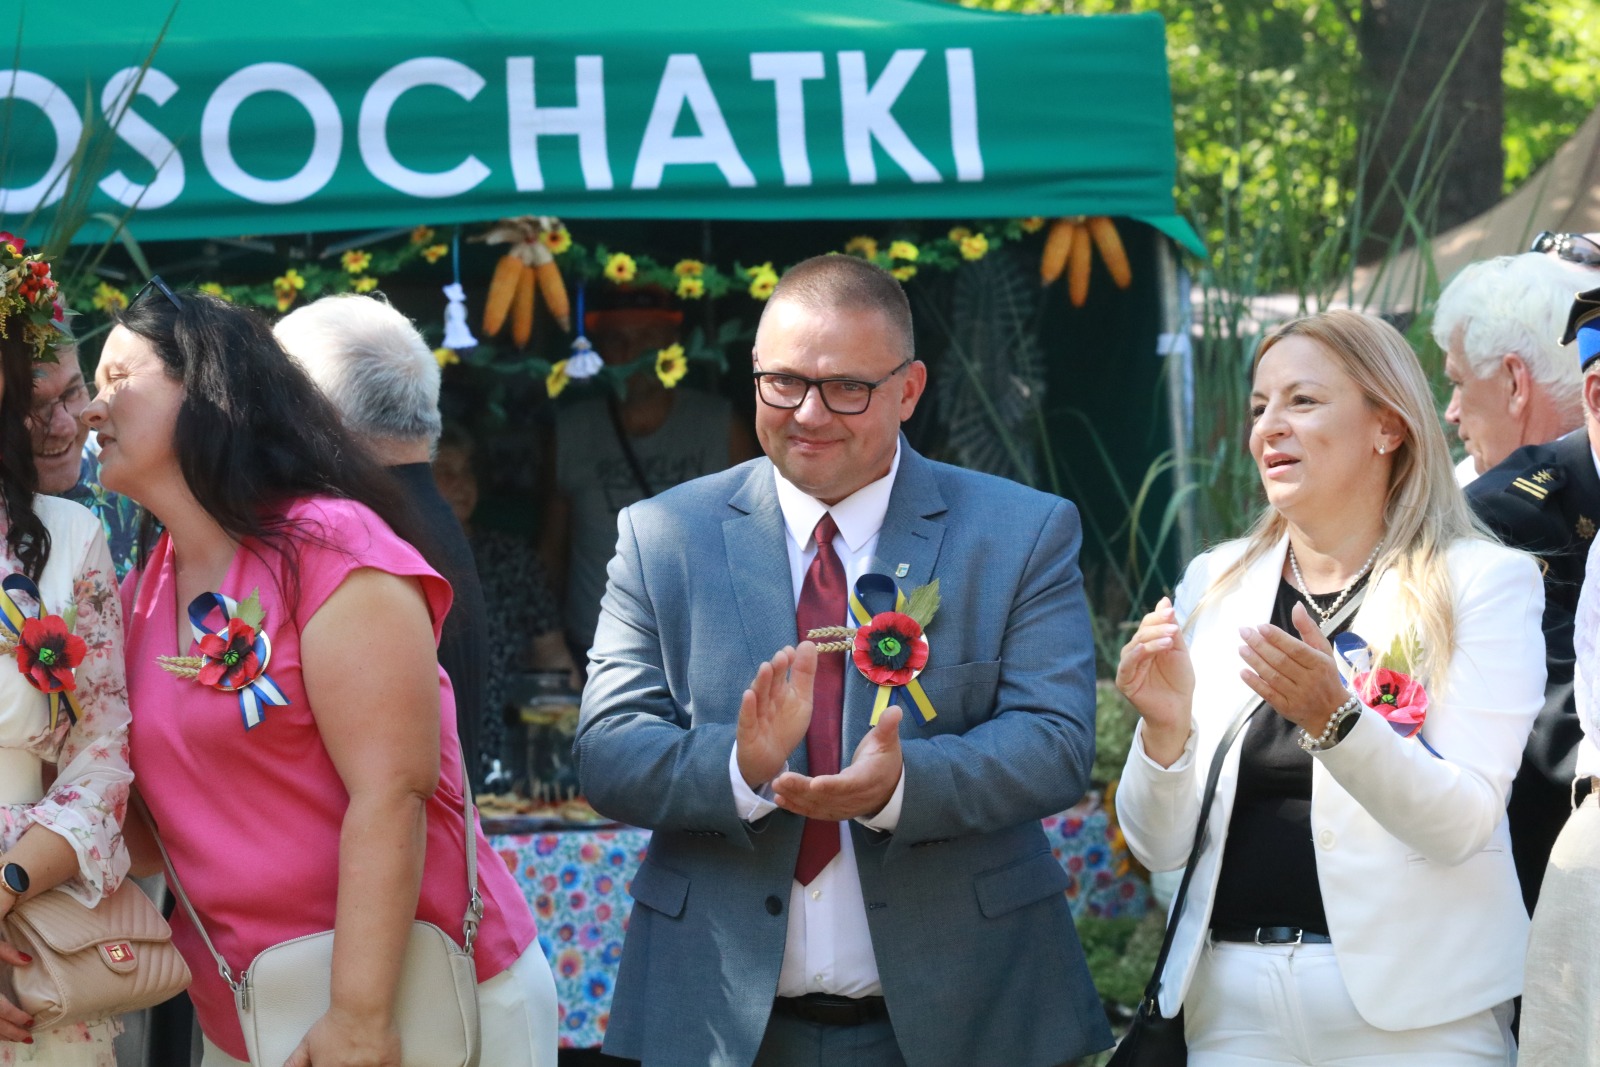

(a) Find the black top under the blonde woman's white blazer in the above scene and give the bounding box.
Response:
[1211,576,1366,934]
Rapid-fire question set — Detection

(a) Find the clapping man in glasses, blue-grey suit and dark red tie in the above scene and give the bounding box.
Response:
[576,256,1110,1067]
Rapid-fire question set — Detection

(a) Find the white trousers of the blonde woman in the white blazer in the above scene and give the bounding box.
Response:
[1184,942,1517,1067]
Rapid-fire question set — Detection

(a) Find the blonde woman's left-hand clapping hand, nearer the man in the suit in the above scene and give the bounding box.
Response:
[1117,597,1195,766]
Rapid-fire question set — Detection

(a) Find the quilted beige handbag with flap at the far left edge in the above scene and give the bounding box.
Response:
[5,878,189,1032]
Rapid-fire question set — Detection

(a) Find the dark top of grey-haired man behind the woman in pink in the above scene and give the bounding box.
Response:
[389,462,490,789]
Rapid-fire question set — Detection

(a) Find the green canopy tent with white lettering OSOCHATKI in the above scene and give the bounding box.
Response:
[0,0,1200,251]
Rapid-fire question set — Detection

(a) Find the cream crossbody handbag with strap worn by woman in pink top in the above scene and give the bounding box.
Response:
[150,763,483,1067]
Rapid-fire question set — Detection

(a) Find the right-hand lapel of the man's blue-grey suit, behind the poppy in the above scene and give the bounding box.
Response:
[840,438,946,755]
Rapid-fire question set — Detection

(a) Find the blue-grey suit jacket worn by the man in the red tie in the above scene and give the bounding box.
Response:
[574,442,1110,1067]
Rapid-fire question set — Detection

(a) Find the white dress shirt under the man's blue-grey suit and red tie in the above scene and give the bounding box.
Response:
[728,443,906,997]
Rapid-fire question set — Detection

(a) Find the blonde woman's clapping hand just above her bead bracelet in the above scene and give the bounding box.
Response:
[1238,603,1349,737]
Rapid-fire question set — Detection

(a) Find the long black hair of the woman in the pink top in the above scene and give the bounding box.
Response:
[118,290,453,603]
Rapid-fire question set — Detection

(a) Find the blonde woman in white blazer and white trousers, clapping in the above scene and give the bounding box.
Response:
[1117,312,1544,1067]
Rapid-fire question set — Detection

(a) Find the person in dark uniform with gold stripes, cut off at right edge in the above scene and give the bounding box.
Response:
[1467,288,1600,913]
